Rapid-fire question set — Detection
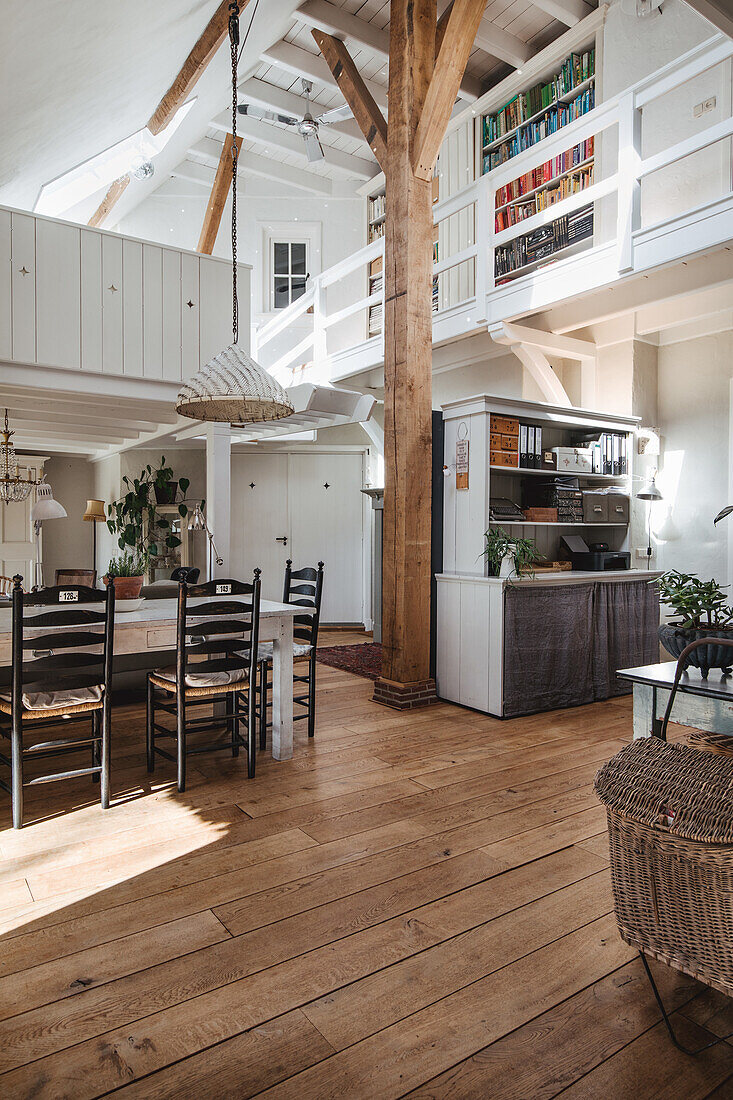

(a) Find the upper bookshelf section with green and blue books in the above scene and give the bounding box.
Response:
[480,45,595,175]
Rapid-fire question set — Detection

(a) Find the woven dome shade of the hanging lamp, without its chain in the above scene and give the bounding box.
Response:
[176,343,295,424]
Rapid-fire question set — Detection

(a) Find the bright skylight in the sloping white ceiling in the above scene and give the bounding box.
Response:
[34,98,196,217]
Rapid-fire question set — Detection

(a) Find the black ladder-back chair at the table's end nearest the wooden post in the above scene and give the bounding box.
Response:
[258,558,324,749]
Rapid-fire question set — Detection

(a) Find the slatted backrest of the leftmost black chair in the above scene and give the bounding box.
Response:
[11,576,114,715]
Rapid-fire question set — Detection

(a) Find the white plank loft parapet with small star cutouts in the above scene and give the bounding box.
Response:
[0,208,250,382]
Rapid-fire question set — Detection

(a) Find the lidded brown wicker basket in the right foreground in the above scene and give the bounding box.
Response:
[595,737,733,997]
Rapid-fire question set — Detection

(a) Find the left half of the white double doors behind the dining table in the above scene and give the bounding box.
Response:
[231,453,291,602]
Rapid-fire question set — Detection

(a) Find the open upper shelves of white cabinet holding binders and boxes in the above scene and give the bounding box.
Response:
[435,396,637,573]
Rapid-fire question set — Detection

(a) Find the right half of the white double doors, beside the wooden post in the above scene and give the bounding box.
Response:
[288,453,364,623]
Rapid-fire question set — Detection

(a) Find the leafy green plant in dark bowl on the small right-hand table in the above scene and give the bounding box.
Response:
[656,569,733,680]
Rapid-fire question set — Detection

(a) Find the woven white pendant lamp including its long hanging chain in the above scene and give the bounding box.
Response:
[176,0,295,425]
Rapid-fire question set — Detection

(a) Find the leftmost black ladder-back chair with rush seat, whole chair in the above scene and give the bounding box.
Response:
[0,576,114,828]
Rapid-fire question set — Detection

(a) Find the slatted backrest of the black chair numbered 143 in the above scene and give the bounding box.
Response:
[176,569,261,694]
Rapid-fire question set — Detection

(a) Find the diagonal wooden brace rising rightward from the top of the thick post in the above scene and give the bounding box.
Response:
[412,0,485,179]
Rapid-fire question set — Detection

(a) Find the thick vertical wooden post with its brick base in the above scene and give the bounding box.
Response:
[374,0,436,708]
